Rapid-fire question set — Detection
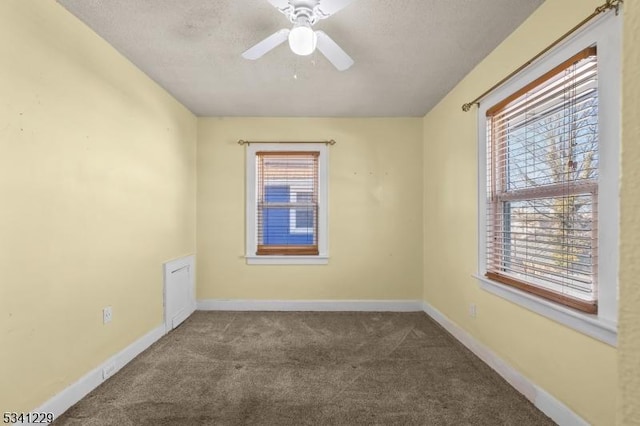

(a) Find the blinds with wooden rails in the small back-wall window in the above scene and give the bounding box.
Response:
[256,151,320,255]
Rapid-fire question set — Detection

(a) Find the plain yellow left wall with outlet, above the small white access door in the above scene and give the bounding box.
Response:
[0,0,197,412]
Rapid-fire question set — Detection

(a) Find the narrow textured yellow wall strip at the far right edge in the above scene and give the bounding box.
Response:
[618,0,640,425]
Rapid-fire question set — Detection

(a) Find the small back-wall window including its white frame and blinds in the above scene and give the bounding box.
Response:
[246,143,327,264]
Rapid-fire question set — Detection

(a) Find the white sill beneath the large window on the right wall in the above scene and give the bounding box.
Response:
[474,275,618,347]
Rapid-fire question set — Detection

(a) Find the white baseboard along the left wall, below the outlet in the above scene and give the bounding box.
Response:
[31,324,165,424]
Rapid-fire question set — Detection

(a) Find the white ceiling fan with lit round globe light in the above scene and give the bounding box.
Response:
[242,0,353,71]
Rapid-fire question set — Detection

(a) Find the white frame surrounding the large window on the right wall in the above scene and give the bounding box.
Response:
[475,13,622,346]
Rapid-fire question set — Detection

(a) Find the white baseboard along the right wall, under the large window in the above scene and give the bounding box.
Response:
[423,302,589,426]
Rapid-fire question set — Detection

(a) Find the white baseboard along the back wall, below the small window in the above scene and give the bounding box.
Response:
[198,299,422,312]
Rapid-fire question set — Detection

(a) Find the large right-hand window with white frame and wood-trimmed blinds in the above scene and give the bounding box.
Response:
[478,14,620,344]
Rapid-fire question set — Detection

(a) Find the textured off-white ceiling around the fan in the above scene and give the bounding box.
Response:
[59,0,543,117]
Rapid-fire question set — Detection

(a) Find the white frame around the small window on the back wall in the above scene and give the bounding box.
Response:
[245,143,329,265]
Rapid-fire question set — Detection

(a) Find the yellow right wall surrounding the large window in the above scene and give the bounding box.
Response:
[424,0,624,425]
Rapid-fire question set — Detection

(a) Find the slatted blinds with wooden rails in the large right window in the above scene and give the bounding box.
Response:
[486,47,599,313]
